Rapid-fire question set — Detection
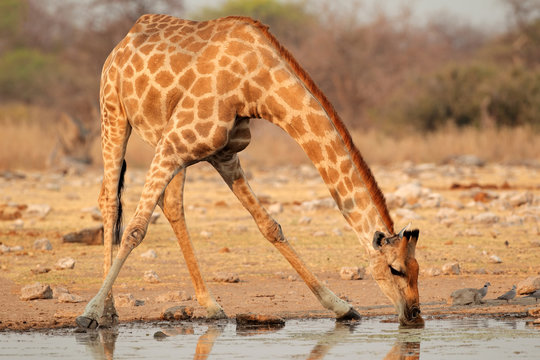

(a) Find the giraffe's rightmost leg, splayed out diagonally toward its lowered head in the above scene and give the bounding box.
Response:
[210,154,360,320]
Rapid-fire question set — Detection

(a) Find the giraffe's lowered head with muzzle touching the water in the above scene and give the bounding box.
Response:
[371,229,424,326]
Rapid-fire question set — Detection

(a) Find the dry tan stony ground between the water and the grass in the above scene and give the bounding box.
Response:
[0,164,540,330]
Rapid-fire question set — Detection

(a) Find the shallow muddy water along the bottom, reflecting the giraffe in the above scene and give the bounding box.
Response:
[0,318,540,360]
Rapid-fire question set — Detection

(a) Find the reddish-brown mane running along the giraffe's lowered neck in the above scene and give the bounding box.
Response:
[228,16,394,234]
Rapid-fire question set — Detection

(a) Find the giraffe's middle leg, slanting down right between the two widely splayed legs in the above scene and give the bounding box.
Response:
[159,169,227,319]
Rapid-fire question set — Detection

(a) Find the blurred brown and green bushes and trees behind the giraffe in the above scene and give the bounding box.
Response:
[0,0,540,169]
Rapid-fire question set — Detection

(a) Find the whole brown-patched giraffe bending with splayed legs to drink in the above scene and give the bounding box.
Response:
[76,15,423,328]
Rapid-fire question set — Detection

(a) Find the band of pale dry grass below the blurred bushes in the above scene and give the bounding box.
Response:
[0,105,540,170]
